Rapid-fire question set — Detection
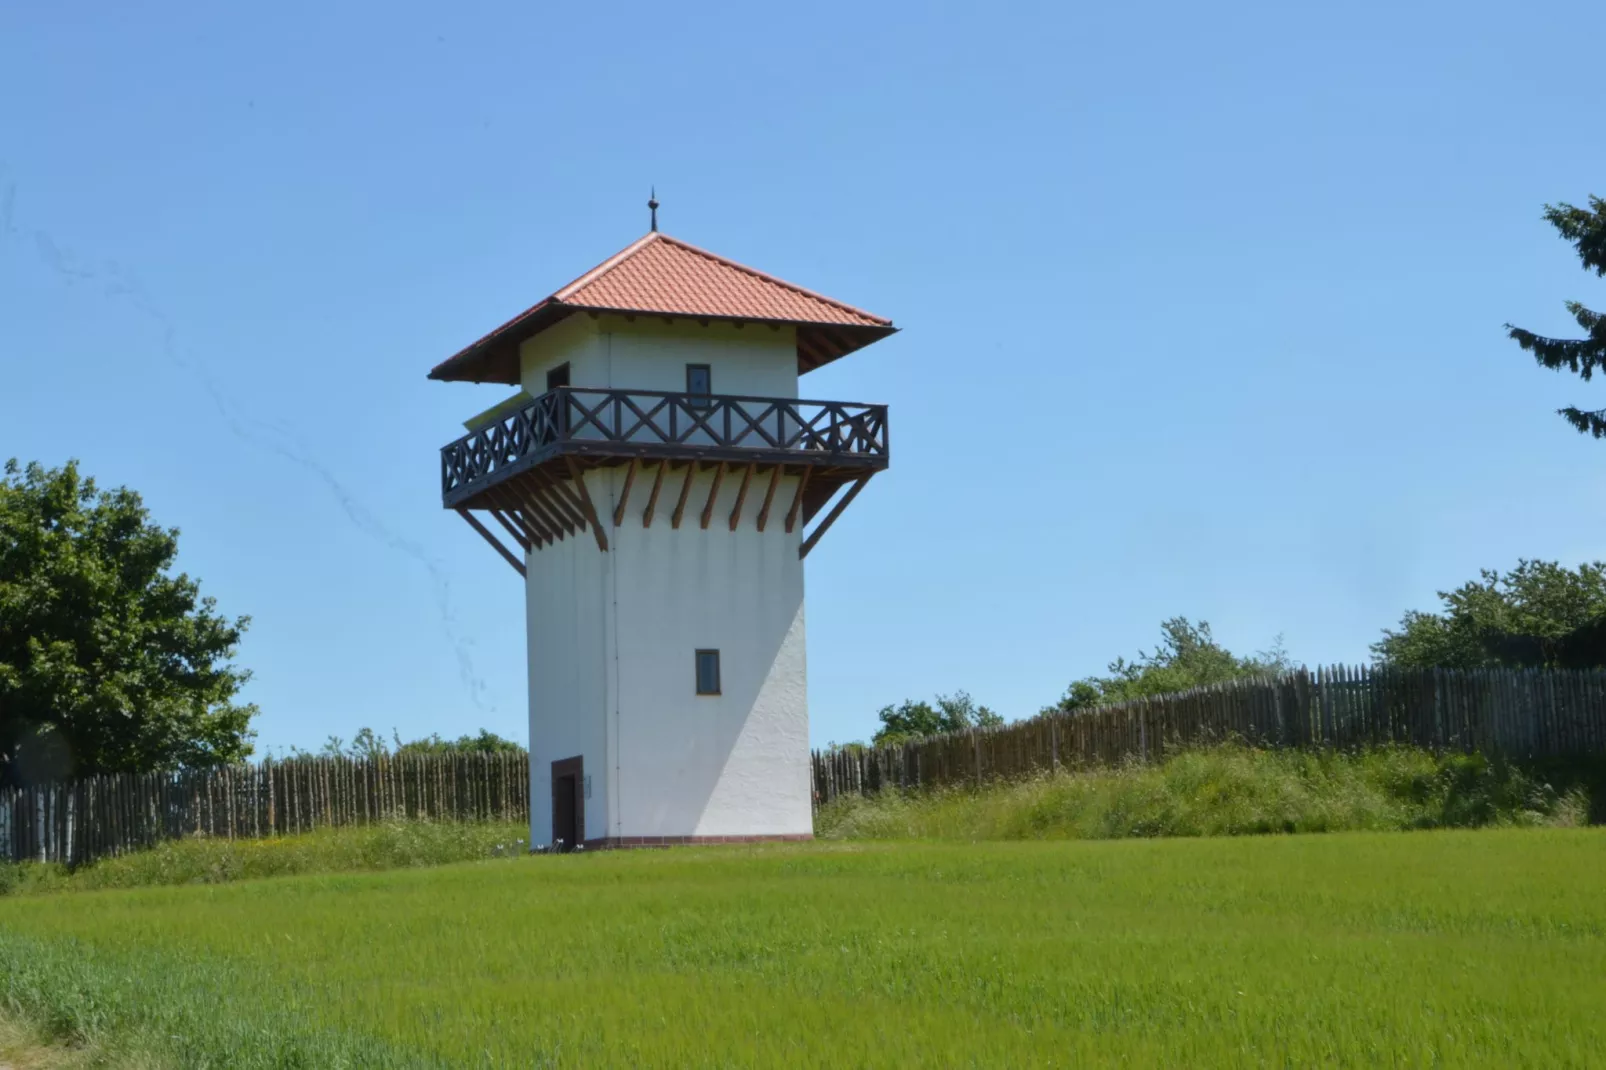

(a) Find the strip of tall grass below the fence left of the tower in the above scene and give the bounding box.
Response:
[0,821,528,895]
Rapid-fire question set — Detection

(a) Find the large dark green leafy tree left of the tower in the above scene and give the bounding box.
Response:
[0,461,257,784]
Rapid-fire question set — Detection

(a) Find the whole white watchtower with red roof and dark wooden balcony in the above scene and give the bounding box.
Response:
[430,202,895,847]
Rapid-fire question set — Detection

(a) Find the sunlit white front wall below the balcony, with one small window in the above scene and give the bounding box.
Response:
[593,469,813,835]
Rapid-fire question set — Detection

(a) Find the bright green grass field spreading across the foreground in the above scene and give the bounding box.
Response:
[0,829,1606,1067]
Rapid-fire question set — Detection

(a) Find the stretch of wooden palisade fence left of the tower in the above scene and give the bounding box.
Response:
[0,753,530,864]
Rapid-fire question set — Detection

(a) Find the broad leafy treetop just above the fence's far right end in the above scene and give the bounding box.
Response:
[1372,561,1606,668]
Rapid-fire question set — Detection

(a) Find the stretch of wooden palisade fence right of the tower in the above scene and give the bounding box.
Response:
[813,667,1606,805]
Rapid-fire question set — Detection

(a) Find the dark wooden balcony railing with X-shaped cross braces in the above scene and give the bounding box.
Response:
[440,387,888,506]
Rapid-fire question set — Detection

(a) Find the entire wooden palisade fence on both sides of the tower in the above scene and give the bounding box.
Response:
[12,668,1606,864]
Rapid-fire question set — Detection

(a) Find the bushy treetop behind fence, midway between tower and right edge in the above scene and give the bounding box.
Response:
[1044,617,1293,713]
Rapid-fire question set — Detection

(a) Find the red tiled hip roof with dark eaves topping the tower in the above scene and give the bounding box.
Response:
[429,231,896,384]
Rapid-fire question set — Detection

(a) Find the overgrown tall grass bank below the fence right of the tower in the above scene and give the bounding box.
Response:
[814,745,1590,840]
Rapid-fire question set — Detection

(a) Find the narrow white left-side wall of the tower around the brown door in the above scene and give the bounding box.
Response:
[525,514,613,845]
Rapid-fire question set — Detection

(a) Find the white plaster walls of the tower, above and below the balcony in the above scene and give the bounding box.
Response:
[520,313,813,843]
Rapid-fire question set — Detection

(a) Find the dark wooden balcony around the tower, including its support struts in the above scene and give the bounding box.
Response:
[440,387,890,572]
